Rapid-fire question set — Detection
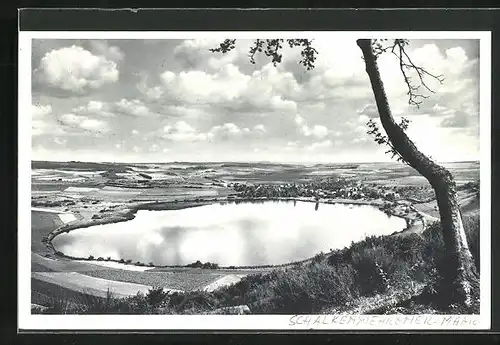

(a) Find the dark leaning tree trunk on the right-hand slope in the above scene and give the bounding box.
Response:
[357,39,478,306]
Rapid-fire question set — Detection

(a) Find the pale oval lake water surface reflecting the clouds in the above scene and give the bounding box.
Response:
[53,201,406,266]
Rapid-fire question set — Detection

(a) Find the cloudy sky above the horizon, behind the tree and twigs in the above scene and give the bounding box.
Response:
[31,33,479,163]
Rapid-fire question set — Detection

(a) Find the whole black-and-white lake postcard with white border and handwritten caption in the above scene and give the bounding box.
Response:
[18,31,491,329]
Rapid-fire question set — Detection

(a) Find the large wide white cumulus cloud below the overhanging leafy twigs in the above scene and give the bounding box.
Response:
[138,60,299,113]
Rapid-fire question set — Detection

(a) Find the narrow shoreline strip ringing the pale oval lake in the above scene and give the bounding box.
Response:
[46,197,425,271]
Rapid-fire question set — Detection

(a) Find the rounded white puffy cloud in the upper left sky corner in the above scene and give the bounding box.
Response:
[35,45,119,92]
